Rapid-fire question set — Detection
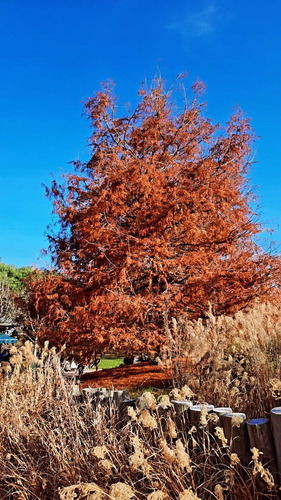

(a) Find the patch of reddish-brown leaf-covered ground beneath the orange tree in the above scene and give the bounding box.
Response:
[80,363,171,389]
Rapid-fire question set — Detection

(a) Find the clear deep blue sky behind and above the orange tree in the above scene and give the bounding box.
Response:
[0,0,281,266]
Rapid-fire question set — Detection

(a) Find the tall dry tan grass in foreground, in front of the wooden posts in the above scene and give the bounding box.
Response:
[0,343,275,500]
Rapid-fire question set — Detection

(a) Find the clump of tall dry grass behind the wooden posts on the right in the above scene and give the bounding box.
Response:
[164,304,281,418]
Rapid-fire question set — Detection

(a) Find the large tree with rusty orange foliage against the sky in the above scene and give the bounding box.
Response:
[29,79,280,358]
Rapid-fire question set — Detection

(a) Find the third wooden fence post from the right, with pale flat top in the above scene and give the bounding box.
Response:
[222,413,251,465]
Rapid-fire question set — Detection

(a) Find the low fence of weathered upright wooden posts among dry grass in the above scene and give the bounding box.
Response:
[79,388,281,478]
